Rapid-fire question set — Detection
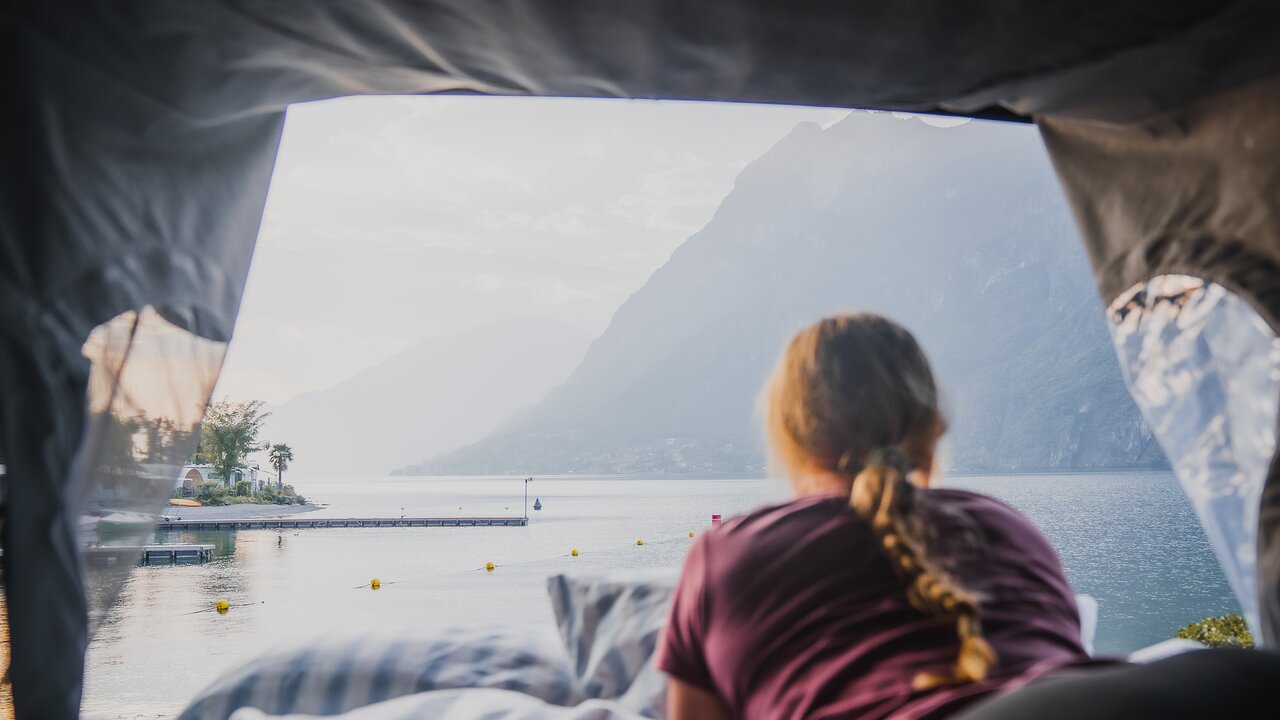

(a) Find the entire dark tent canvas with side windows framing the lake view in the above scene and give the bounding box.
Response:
[0,0,1280,717]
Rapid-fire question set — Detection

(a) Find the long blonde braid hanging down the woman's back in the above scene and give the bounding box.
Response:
[842,447,996,691]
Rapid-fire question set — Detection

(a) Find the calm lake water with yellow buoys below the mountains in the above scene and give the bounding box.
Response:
[84,473,1236,717]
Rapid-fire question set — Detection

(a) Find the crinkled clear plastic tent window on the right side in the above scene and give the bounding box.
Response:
[1107,275,1280,644]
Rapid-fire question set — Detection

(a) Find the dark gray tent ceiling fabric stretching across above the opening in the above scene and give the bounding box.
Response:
[15,0,1280,122]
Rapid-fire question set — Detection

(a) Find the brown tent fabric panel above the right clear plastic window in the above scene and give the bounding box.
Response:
[1039,73,1280,329]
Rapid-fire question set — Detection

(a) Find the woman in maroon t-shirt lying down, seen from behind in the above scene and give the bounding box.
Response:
[659,314,1091,720]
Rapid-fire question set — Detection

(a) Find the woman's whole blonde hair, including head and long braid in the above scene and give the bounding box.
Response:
[765,313,996,689]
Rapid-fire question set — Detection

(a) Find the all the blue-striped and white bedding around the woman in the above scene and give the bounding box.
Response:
[180,569,1121,720]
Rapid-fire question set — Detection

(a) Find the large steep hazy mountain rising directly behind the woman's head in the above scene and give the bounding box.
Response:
[416,113,1166,474]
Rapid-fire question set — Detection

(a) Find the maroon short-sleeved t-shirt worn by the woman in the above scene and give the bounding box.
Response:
[658,489,1088,719]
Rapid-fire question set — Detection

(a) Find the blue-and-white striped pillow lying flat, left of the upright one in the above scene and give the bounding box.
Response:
[179,626,585,720]
